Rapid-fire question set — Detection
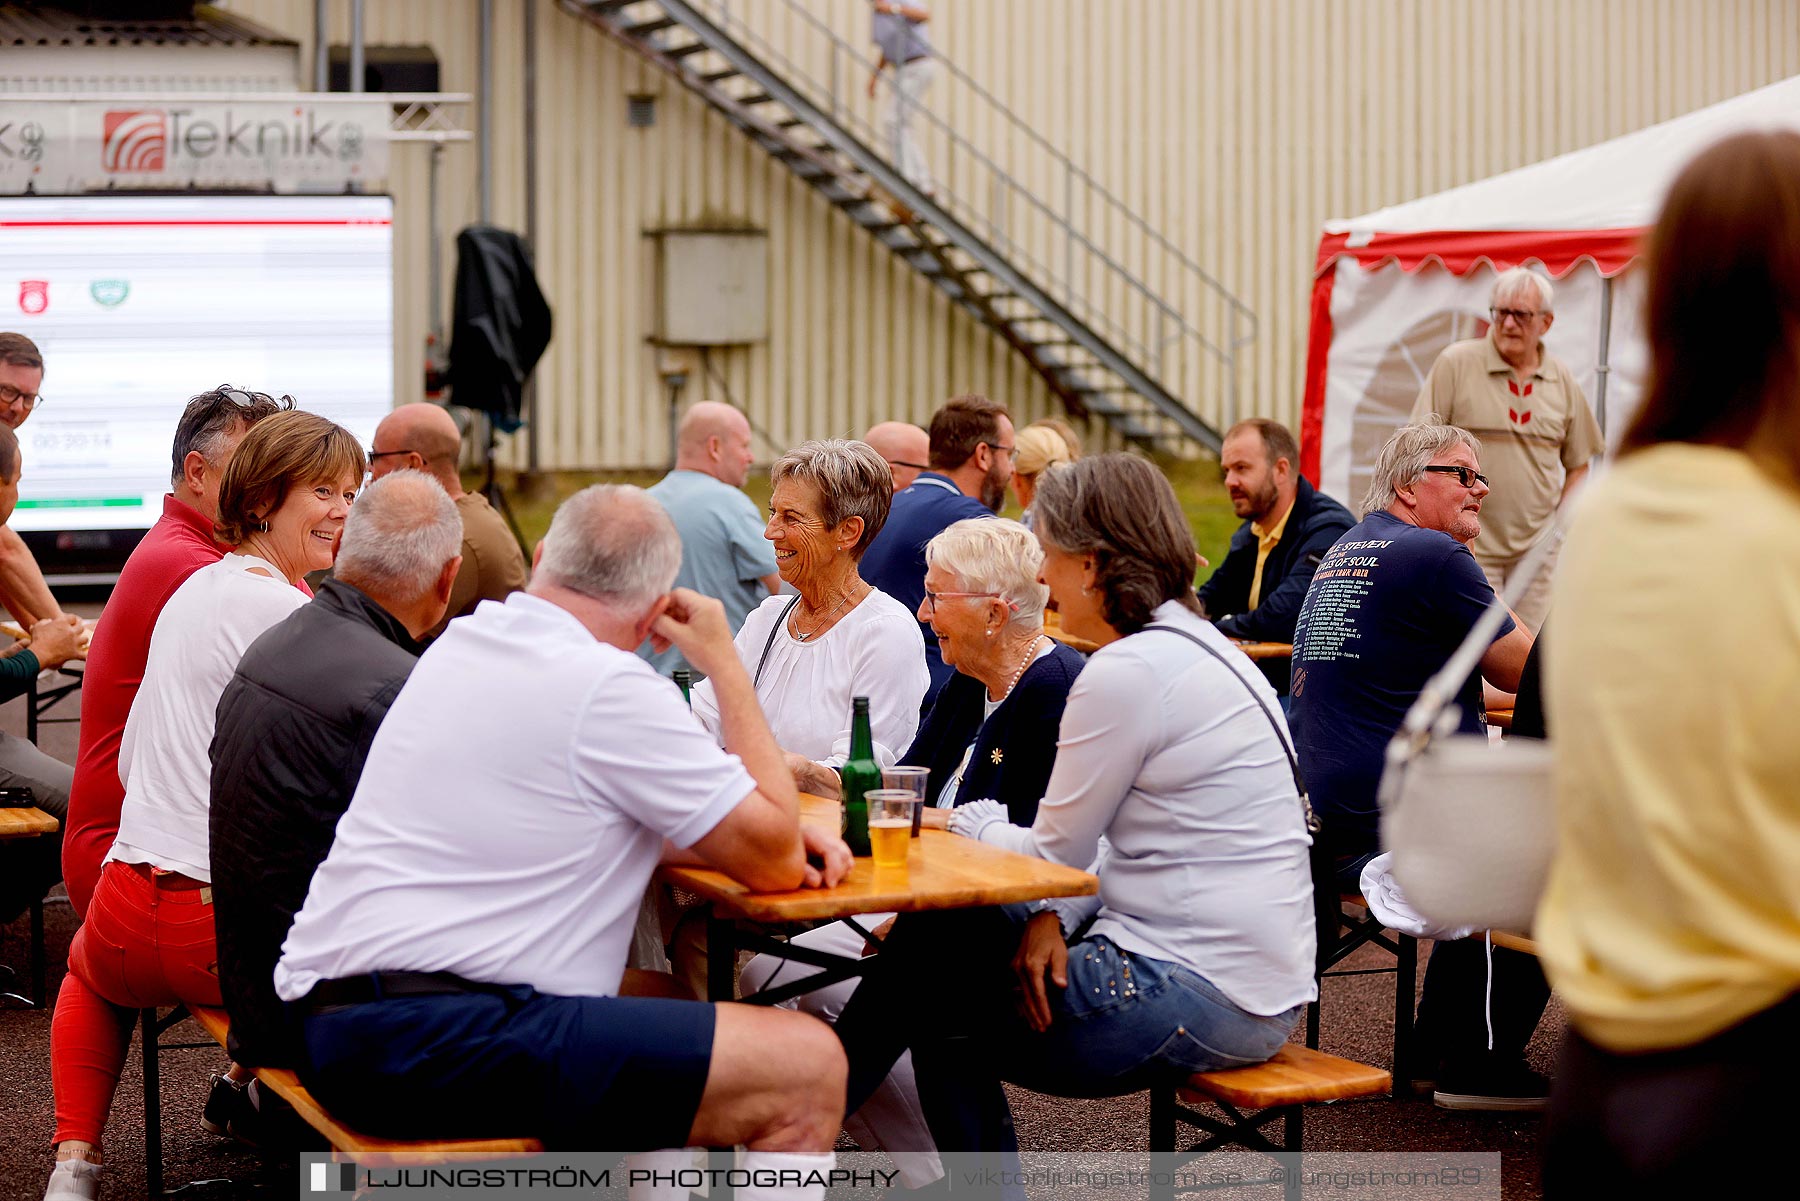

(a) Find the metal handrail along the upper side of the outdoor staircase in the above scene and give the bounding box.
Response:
[689,0,1256,418]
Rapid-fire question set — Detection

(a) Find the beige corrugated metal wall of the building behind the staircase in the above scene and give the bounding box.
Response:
[217,0,1800,468]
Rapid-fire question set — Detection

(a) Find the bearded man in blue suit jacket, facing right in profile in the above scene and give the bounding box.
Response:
[857,396,1013,709]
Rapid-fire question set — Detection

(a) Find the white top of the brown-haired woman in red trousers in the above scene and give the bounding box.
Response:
[106,555,306,880]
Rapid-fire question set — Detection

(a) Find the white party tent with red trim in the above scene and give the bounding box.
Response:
[1301,76,1800,506]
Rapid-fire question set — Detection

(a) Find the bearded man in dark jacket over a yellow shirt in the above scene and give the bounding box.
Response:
[1201,418,1355,697]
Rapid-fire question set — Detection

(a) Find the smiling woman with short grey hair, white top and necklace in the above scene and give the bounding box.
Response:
[693,438,931,796]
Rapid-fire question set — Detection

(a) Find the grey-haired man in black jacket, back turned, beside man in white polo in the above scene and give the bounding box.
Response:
[211,472,463,1068]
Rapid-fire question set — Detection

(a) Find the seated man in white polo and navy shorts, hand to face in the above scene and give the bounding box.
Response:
[275,486,850,1197]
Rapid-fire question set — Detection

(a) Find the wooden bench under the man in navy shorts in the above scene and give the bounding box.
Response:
[142,1005,544,1197]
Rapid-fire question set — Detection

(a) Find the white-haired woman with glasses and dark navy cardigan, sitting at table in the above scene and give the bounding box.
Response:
[742,519,1084,1188]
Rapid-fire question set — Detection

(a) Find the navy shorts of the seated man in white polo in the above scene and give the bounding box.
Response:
[301,987,715,1151]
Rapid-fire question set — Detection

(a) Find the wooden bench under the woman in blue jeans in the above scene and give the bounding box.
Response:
[1150,1043,1393,1201]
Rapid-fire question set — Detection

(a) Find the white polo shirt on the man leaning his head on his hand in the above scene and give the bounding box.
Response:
[275,592,756,1001]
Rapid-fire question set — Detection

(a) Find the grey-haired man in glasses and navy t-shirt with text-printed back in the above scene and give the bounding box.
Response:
[1289,423,1550,1111]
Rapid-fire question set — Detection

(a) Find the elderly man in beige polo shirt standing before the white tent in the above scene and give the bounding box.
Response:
[1411,266,1604,634]
